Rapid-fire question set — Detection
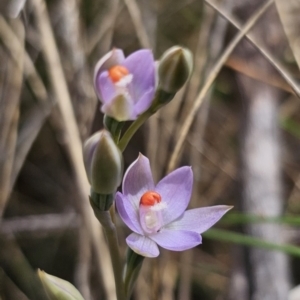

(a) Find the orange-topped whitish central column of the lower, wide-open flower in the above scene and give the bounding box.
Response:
[139,191,166,234]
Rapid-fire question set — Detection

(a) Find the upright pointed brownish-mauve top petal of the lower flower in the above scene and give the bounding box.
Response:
[123,154,154,210]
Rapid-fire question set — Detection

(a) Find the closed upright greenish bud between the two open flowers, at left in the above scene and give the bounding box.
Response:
[83,129,123,194]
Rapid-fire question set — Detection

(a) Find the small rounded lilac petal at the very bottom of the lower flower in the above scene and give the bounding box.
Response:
[126,233,159,257]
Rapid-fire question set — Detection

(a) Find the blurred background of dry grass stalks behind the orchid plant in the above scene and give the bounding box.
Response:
[0,0,300,300]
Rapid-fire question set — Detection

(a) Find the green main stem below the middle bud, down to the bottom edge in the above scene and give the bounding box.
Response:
[90,199,126,300]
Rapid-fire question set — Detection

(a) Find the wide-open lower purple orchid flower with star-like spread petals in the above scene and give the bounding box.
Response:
[116,154,232,257]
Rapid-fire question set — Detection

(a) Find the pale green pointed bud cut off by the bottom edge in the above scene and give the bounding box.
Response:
[38,270,84,300]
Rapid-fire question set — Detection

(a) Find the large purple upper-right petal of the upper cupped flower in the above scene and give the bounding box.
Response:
[123,49,155,101]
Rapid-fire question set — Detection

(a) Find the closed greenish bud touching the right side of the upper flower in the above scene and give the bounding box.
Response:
[158,46,193,93]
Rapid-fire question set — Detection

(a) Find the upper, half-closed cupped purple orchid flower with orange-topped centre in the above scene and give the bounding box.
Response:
[94,49,156,121]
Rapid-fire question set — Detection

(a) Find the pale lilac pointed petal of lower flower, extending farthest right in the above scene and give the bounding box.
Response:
[166,205,232,234]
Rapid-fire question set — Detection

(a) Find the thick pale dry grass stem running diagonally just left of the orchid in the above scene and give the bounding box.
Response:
[31,0,115,299]
